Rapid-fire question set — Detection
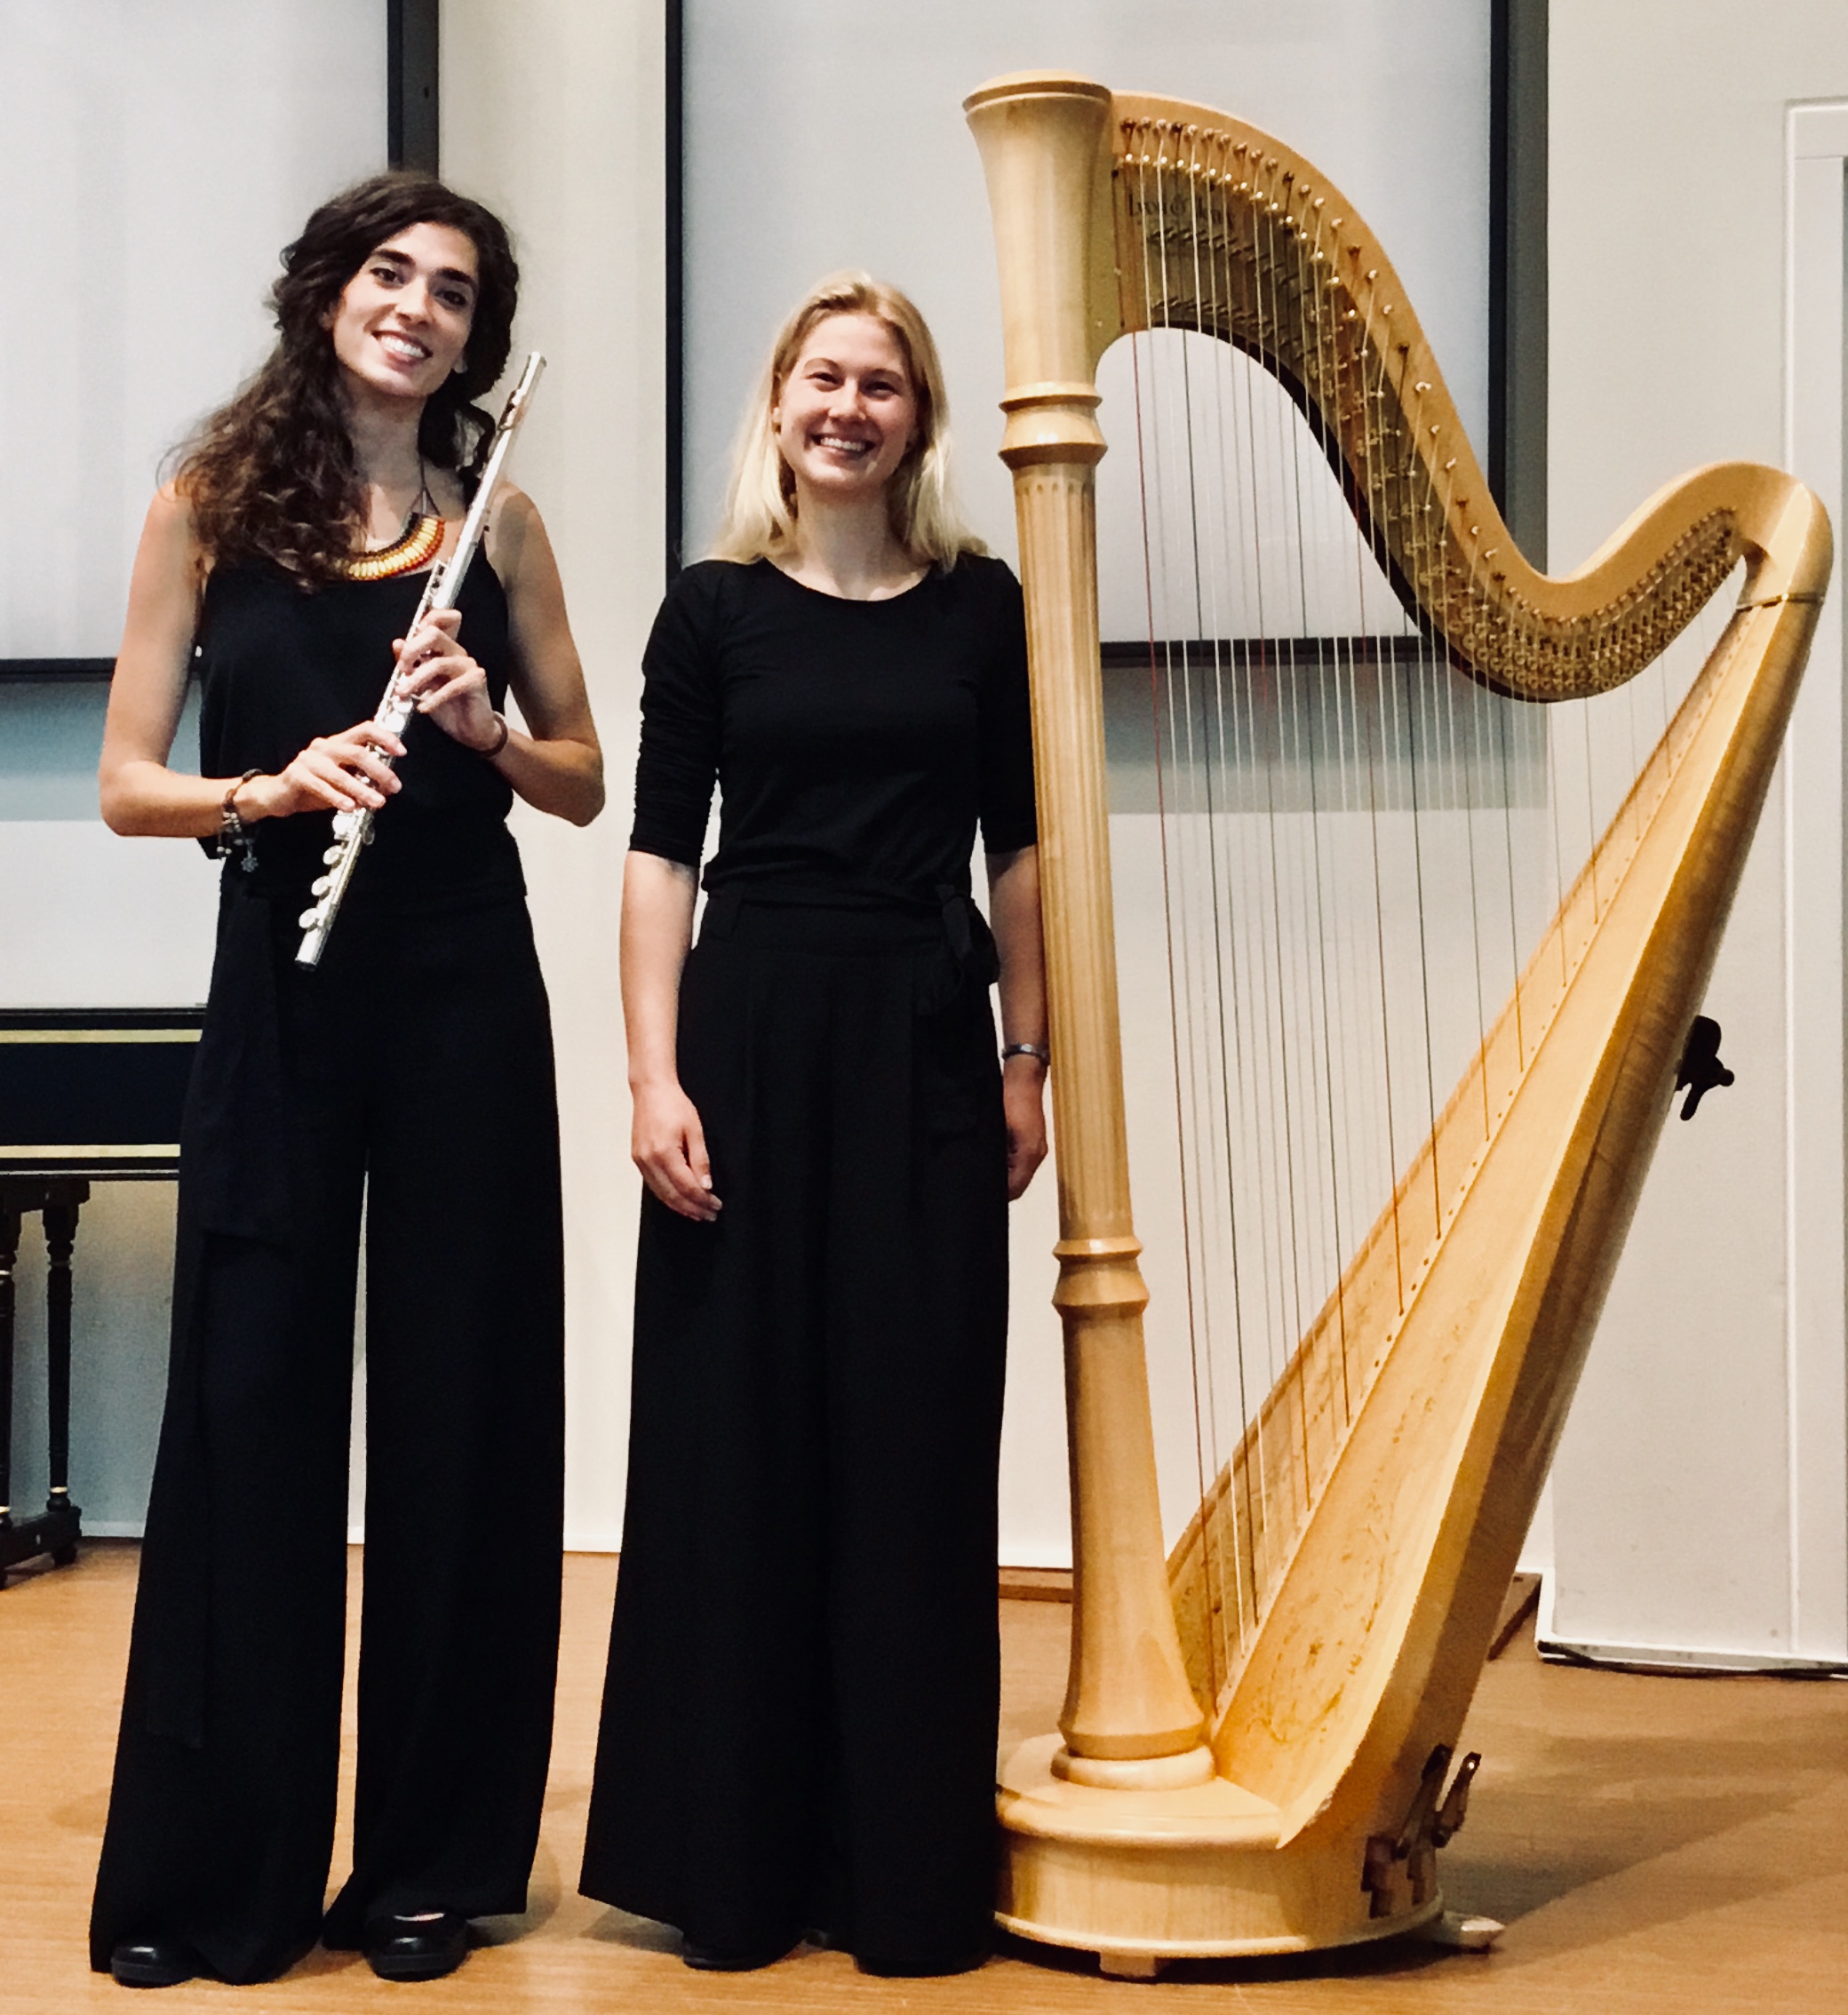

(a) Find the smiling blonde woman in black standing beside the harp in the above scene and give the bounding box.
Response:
[583,274,1046,1975]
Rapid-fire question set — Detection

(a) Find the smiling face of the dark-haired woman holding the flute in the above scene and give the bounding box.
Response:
[326,224,480,399]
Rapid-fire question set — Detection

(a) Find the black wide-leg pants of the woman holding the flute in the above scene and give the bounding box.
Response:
[91,877,562,1980]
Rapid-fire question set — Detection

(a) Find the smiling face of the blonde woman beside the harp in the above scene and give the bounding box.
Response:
[769,315,917,502]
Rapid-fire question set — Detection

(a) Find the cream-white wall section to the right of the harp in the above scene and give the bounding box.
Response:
[1543,0,1848,1661]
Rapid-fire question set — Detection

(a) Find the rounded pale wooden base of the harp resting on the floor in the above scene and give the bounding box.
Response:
[996,1735,1443,1979]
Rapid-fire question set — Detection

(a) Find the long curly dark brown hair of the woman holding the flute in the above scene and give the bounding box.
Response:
[175,170,520,586]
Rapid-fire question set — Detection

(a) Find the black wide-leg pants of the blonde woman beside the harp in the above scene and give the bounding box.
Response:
[583,899,1008,1972]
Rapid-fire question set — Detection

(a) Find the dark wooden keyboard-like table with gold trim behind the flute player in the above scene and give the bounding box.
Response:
[0,1008,205,1588]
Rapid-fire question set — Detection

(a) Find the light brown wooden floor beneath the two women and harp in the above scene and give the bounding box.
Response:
[0,1541,1848,2015]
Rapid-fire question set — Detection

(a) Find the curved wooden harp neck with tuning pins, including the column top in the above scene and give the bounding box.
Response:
[965,73,1832,699]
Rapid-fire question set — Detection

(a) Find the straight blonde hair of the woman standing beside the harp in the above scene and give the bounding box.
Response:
[712,272,987,566]
